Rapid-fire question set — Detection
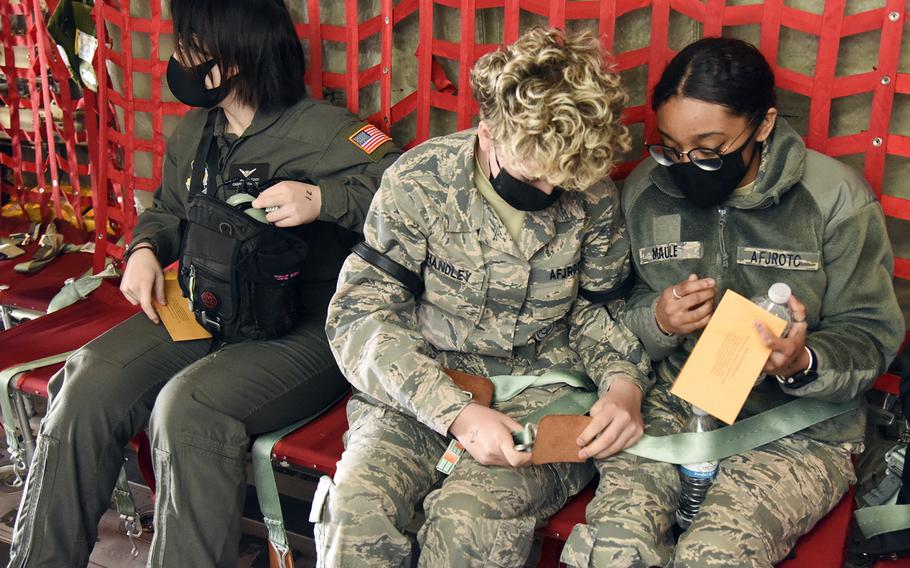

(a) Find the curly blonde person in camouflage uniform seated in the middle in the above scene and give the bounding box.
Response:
[312,29,648,567]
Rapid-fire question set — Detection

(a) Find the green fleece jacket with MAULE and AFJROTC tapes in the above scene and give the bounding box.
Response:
[622,119,904,442]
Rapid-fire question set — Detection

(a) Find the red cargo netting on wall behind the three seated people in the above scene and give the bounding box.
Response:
[83,0,910,320]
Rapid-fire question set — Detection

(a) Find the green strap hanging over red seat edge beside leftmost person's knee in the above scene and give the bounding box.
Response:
[252,415,332,566]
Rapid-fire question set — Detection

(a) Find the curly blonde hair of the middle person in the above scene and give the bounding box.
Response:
[471,28,630,190]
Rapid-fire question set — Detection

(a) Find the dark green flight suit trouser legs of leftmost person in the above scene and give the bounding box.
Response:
[9,314,347,568]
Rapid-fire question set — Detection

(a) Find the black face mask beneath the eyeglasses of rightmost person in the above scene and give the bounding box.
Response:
[668,128,761,208]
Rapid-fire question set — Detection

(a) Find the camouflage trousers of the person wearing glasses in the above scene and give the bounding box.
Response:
[561,386,855,568]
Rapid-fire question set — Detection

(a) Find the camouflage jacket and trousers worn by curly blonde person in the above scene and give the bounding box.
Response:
[316,131,650,566]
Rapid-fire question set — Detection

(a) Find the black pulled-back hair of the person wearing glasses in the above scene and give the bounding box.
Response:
[651,37,777,121]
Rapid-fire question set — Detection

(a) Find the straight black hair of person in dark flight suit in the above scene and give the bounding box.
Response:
[170,0,306,110]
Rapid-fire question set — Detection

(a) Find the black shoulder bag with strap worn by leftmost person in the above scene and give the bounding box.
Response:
[179,109,308,343]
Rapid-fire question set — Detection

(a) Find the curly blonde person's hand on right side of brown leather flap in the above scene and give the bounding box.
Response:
[575,380,645,459]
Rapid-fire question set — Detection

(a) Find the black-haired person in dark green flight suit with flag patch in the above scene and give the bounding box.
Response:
[10,0,399,568]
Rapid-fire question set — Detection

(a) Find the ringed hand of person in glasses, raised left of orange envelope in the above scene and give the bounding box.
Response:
[654,274,717,335]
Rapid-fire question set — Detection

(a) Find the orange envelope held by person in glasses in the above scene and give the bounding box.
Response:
[670,290,787,424]
